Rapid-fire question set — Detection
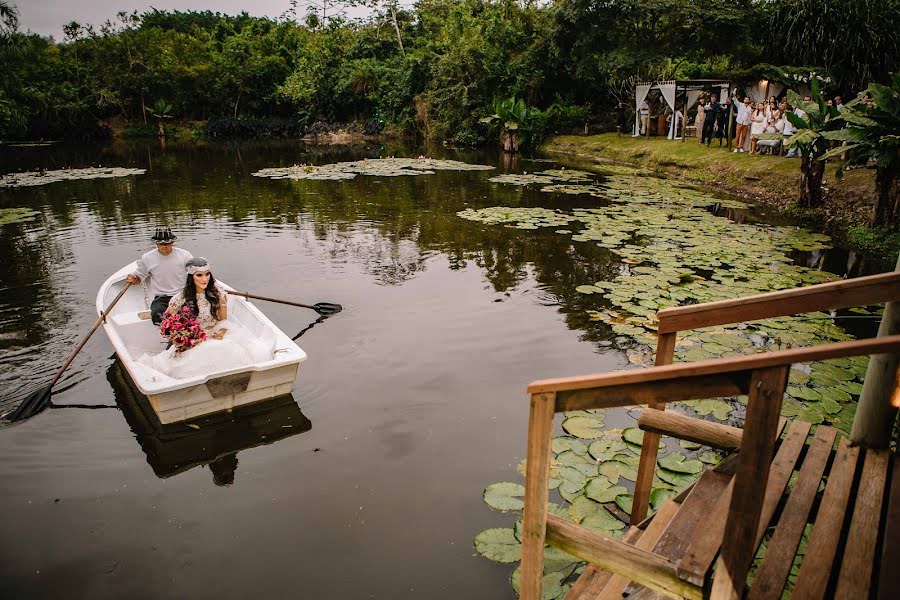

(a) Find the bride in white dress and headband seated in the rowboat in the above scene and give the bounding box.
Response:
[138,257,272,379]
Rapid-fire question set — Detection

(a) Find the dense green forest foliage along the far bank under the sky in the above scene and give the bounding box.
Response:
[0,0,900,140]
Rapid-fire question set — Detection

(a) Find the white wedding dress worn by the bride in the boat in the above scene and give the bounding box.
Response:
[138,292,272,379]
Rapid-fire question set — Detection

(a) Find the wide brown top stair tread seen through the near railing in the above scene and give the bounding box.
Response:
[623,471,731,598]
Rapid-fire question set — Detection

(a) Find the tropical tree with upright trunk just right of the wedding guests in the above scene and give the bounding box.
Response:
[784,78,843,208]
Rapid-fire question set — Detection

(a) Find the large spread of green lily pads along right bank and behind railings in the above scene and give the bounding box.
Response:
[468,165,879,598]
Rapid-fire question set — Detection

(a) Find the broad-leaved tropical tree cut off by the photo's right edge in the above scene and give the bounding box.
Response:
[820,73,900,227]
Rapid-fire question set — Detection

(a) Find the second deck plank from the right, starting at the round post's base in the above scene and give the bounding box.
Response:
[834,449,896,600]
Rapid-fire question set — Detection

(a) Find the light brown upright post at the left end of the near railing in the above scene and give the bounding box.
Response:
[519,394,556,600]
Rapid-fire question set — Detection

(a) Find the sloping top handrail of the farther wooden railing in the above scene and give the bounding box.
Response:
[657,272,900,333]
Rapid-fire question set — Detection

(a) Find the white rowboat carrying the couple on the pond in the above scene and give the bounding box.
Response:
[97,263,306,424]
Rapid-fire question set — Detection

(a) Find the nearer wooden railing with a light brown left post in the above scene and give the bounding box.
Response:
[521,335,900,600]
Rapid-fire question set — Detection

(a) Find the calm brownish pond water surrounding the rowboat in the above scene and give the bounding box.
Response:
[0,139,872,599]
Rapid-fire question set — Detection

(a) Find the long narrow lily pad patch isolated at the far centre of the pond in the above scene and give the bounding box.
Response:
[253,157,494,181]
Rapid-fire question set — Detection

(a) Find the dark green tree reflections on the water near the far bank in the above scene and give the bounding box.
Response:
[0,143,856,358]
